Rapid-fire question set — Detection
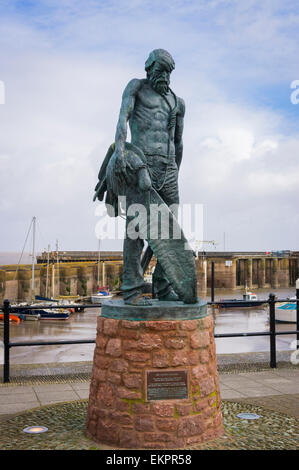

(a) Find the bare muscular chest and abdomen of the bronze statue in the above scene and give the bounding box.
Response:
[129,80,176,156]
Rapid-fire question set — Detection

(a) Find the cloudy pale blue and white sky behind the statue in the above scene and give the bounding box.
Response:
[0,0,299,251]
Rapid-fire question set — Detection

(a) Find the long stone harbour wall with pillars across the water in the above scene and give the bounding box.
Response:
[0,252,299,302]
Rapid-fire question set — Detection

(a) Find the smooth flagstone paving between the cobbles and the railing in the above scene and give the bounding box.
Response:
[0,366,299,419]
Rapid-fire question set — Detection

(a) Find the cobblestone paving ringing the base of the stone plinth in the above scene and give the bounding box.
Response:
[0,400,299,450]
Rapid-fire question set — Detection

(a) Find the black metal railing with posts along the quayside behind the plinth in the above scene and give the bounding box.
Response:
[2,289,299,383]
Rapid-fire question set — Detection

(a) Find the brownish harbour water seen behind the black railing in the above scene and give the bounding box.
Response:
[0,288,296,364]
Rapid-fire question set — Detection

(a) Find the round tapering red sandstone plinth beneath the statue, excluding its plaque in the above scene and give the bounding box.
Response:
[86,315,223,449]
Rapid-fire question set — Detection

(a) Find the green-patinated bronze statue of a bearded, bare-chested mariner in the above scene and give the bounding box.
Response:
[94,49,197,306]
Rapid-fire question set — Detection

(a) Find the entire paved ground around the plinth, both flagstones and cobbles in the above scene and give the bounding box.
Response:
[0,362,299,451]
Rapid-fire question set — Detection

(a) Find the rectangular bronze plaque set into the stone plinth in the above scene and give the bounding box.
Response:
[146,370,188,400]
